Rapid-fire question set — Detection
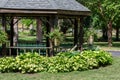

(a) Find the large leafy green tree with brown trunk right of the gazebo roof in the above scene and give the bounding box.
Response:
[78,0,120,46]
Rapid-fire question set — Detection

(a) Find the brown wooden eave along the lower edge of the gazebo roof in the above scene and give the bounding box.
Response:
[0,8,91,16]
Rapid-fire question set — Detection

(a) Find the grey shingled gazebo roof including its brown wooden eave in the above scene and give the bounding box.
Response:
[0,0,90,15]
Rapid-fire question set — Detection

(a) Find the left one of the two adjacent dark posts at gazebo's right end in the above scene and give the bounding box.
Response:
[74,18,78,49]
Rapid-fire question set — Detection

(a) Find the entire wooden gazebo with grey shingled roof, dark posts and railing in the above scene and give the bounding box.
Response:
[0,0,90,56]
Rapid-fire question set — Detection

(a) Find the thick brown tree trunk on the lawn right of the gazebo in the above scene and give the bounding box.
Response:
[107,21,112,47]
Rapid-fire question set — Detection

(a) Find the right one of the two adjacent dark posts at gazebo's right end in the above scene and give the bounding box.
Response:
[79,16,84,51]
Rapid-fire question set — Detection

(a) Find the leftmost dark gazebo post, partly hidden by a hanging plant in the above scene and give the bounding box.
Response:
[2,15,7,56]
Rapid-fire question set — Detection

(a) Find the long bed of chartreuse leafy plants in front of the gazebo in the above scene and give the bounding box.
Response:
[0,51,113,73]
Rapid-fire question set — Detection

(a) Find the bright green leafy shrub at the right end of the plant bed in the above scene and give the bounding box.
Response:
[81,50,113,68]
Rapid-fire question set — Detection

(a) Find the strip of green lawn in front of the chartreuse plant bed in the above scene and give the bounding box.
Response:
[0,57,120,80]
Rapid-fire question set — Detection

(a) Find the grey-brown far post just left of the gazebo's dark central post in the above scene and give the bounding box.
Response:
[36,18,42,44]
